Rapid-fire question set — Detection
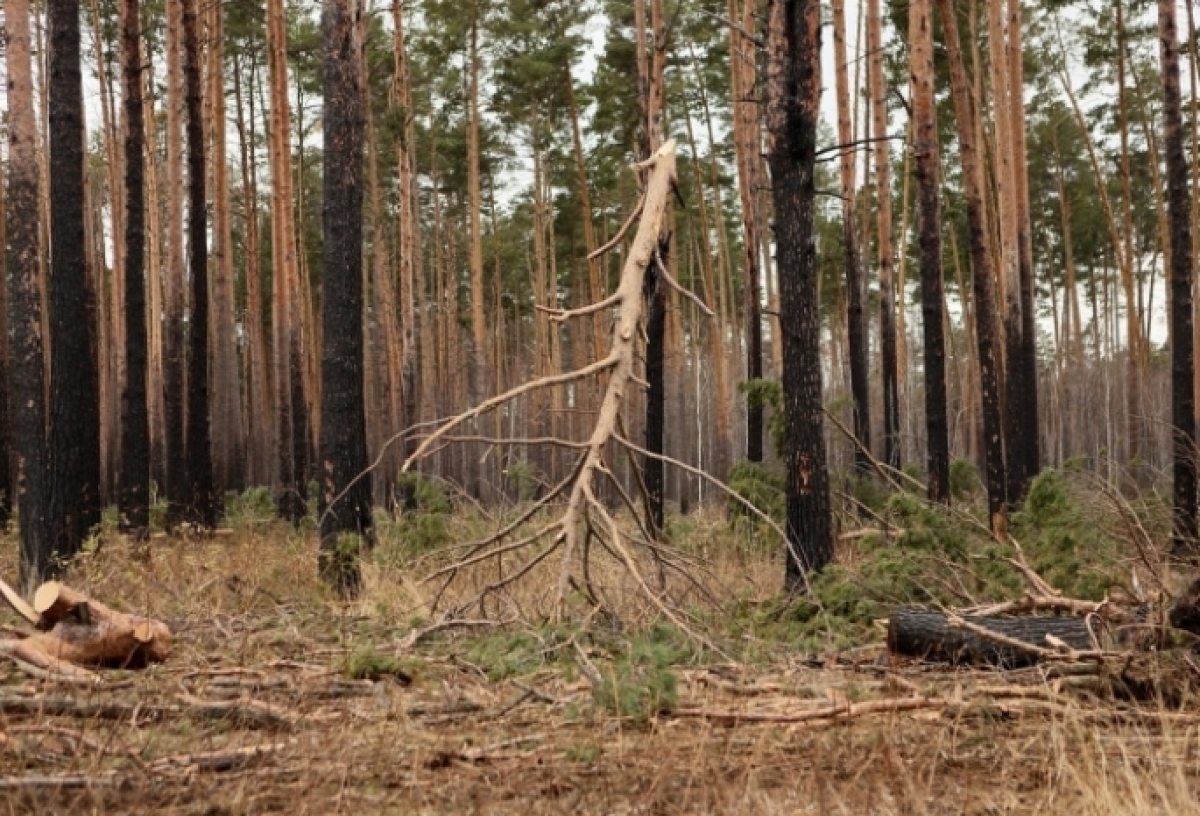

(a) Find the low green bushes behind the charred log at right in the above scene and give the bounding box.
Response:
[730,470,1128,652]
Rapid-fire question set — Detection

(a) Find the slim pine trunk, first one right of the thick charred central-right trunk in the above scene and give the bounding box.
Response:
[833,0,871,474]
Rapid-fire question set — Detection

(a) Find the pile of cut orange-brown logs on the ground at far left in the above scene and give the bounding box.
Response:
[0,581,172,683]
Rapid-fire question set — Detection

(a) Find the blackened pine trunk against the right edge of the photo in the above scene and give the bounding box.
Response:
[1158,0,1200,557]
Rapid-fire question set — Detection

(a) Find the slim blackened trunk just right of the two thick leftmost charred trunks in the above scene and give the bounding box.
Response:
[118,0,150,534]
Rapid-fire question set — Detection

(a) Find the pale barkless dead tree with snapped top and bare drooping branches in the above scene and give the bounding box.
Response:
[401,140,712,626]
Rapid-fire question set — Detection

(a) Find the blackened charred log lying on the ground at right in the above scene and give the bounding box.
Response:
[888,607,1094,668]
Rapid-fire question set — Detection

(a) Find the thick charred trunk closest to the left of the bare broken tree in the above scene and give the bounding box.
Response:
[320,0,371,595]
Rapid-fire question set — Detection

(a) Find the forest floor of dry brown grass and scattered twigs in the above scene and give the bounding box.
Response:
[0,487,1200,816]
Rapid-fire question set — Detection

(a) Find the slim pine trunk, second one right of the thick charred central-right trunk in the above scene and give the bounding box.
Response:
[866,0,900,468]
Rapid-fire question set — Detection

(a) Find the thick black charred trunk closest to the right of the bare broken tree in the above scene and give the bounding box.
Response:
[767,0,833,592]
